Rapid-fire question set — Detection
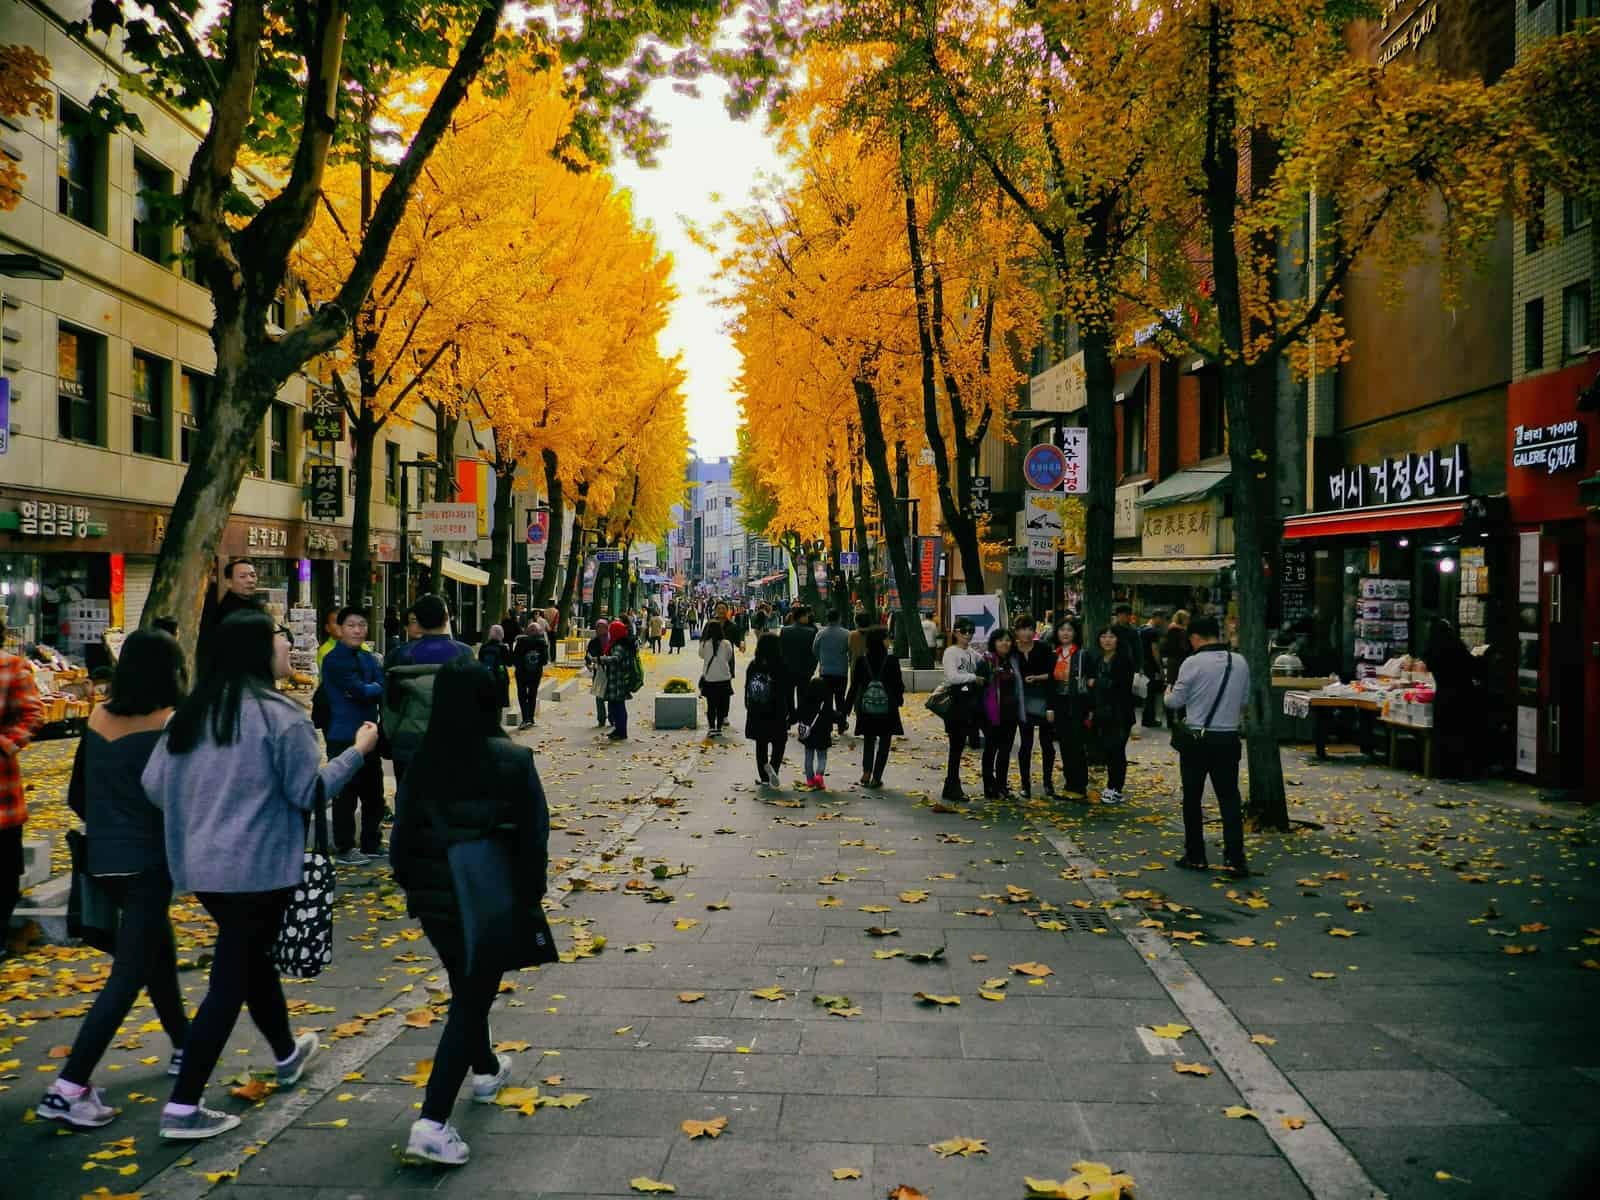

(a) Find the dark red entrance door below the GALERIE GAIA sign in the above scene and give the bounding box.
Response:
[1539,522,1587,787]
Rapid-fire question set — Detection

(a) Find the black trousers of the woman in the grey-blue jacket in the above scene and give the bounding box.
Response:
[173,888,294,1104]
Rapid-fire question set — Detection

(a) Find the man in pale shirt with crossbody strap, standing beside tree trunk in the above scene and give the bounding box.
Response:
[1166,616,1250,877]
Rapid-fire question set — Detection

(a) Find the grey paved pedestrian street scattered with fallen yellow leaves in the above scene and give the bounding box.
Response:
[0,658,1600,1200]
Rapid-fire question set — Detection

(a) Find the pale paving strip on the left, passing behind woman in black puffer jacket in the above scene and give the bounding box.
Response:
[141,750,694,1200]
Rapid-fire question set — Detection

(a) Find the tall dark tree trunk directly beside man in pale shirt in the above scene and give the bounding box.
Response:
[1205,3,1290,830]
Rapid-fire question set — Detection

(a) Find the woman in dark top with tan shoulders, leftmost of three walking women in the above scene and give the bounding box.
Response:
[38,630,189,1128]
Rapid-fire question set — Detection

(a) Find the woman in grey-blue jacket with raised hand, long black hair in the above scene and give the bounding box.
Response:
[142,611,378,1141]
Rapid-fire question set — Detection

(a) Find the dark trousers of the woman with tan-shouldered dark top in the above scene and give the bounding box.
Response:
[61,867,189,1088]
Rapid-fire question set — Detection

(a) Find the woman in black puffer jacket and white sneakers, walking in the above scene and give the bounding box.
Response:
[389,659,550,1166]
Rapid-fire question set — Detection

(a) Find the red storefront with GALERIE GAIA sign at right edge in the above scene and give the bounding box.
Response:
[1506,358,1600,798]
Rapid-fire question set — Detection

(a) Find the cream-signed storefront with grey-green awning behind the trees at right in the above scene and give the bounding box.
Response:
[1112,469,1234,616]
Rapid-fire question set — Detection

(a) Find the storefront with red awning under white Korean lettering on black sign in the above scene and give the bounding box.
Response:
[1277,442,1510,762]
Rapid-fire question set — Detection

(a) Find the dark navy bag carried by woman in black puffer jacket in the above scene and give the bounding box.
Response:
[429,755,560,974]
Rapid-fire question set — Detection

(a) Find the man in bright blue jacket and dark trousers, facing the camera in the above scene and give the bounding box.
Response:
[322,606,384,867]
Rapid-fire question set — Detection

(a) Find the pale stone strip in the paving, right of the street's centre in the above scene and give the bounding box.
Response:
[1045,834,1387,1200]
